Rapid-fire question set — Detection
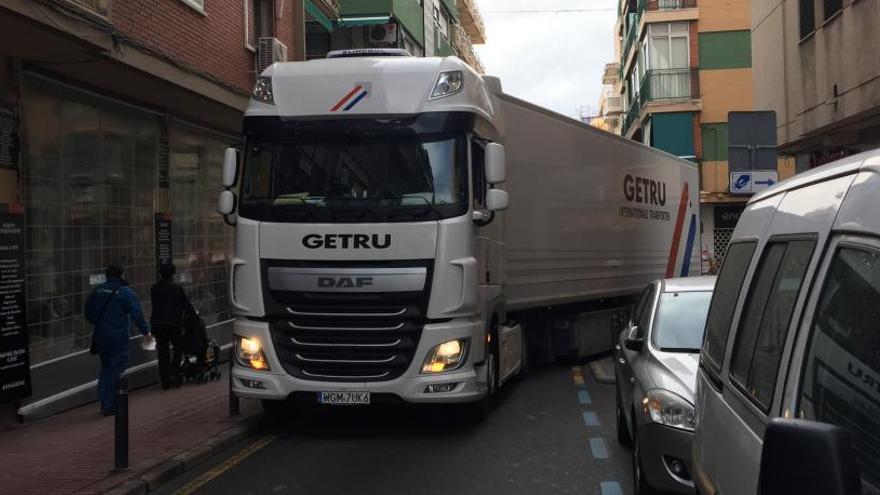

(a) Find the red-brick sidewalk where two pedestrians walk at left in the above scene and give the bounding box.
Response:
[0,369,260,495]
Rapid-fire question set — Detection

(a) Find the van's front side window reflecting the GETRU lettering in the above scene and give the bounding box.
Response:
[798,247,880,493]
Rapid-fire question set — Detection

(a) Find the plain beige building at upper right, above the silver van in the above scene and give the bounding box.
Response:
[751,0,880,172]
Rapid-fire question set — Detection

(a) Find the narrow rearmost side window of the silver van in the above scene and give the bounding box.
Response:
[701,241,757,374]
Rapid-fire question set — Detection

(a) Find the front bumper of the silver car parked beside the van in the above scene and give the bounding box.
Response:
[638,423,694,494]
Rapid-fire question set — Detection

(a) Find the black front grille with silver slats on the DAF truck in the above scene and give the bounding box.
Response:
[263,260,431,382]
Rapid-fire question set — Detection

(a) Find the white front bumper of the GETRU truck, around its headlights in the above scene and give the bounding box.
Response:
[232,318,486,403]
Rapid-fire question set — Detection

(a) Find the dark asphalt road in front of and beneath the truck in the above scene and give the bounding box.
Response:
[155,365,632,495]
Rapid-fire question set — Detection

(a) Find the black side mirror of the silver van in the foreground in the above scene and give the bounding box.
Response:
[758,418,862,495]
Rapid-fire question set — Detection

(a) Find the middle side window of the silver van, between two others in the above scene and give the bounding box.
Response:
[730,241,816,412]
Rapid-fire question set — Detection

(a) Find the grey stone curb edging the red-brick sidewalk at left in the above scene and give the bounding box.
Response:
[104,415,262,495]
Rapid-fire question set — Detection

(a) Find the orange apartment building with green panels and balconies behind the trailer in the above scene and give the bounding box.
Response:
[603,0,792,271]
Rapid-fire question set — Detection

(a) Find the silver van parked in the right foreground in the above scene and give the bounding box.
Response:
[692,150,880,495]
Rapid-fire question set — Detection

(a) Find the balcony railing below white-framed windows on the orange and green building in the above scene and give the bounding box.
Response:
[623,68,700,135]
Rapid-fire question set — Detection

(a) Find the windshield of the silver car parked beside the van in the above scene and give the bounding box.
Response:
[651,291,712,352]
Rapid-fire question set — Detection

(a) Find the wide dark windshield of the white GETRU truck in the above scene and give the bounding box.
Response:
[234,136,469,222]
